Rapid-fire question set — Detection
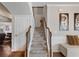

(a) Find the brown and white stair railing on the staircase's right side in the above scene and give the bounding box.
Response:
[42,18,52,57]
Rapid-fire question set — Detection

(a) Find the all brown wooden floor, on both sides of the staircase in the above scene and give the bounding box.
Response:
[0,45,64,57]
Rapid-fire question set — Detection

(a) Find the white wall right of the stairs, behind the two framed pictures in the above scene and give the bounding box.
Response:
[47,4,79,52]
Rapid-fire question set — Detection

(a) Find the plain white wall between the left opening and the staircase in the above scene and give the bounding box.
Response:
[12,15,33,51]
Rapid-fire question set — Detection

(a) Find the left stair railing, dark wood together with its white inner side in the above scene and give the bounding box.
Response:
[25,26,31,57]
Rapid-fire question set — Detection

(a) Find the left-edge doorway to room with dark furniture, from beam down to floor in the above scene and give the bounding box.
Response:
[0,15,12,56]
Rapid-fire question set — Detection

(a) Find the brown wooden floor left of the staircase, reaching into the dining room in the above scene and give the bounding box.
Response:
[0,45,25,57]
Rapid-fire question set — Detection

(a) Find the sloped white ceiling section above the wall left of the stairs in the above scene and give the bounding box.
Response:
[3,2,31,15]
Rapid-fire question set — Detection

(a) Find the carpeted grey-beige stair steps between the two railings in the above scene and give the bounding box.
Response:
[30,28,48,57]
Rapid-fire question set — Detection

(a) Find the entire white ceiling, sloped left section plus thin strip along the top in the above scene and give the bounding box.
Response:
[2,2,79,15]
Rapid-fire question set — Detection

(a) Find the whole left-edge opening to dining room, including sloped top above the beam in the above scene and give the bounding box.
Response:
[0,3,12,57]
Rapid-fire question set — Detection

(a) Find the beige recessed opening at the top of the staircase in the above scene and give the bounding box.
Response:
[32,7,44,28]
